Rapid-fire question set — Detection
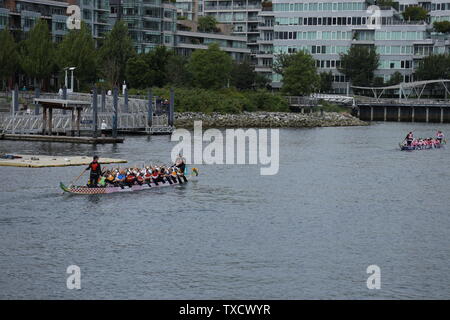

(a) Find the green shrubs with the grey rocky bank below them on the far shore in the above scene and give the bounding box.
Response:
[131,88,367,128]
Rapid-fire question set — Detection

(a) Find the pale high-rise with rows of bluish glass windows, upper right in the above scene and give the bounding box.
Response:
[273,0,450,93]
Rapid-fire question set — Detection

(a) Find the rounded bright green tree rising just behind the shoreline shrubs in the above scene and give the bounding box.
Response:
[187,43,233,89]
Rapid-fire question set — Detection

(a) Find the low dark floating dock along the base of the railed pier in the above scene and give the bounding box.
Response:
[0,133,124,144]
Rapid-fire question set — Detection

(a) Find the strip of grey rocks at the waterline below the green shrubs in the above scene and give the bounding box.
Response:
[175,112,368,128]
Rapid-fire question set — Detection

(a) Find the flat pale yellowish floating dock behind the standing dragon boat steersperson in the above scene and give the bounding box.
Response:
[0,154,128,168]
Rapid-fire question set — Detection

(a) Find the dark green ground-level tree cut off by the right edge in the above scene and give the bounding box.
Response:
[415,54,450,80]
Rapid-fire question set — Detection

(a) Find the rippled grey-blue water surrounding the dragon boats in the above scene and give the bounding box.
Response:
[0,123,450,299]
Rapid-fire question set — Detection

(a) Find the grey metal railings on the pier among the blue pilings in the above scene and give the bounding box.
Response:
[0,91,173,134]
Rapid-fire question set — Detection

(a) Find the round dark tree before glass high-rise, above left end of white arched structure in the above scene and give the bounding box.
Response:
[338,46,380,86]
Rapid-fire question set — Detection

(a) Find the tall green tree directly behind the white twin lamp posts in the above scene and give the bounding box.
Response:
[57,22,97,90]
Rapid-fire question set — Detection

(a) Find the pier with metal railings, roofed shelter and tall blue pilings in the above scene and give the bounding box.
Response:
[0,88,174,137]
